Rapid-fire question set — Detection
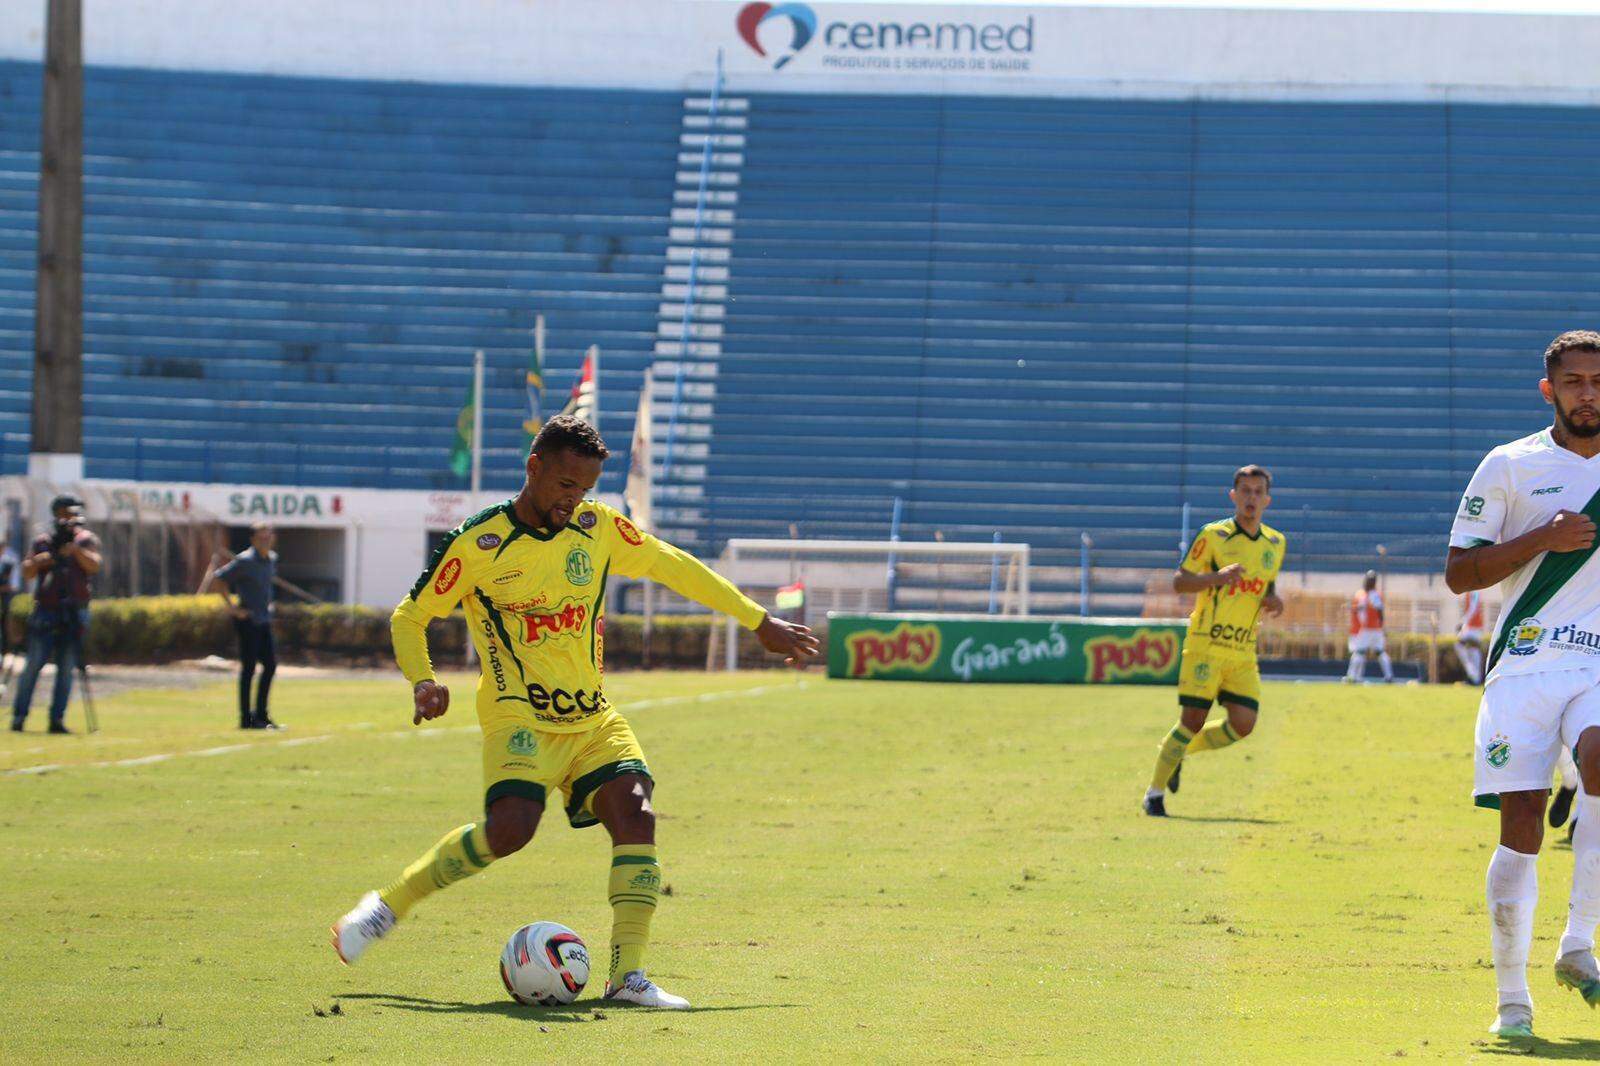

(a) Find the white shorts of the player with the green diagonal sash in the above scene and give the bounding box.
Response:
[1472,666,1600,807]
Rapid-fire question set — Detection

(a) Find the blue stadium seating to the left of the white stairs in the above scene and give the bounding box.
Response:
[0,62,682,491]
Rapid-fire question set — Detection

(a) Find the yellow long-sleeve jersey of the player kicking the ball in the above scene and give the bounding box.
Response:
[390,499,766,733]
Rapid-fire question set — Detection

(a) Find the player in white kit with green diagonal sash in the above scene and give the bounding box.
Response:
[1445,330,1600,1037]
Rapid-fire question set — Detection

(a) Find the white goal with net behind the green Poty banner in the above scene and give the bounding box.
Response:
[706,539,1029,671]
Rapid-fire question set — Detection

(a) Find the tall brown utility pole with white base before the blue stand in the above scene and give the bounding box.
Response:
[27,0,83,483]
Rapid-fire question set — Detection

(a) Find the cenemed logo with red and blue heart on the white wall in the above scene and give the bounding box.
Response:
[736,3,1034,74]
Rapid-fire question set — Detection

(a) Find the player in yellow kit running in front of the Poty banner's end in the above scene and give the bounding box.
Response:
[1144,466,1283,818]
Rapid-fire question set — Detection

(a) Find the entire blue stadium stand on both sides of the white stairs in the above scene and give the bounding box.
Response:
[0,62,1600,591]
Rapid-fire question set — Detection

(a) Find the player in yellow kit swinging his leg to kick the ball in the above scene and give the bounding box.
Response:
[333,416,818,1010]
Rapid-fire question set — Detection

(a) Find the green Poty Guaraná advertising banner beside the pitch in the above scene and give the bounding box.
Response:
[827,613,1184,685]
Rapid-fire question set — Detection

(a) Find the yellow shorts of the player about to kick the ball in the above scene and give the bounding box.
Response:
[483,709,650,829]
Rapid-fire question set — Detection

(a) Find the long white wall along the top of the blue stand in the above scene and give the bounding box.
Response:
[9,0,1600,102]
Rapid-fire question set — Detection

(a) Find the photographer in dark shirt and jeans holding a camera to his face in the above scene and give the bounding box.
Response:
[11,496,101,733]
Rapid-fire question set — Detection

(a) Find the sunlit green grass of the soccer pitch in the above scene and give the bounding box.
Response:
[0,674,1600,1063]
